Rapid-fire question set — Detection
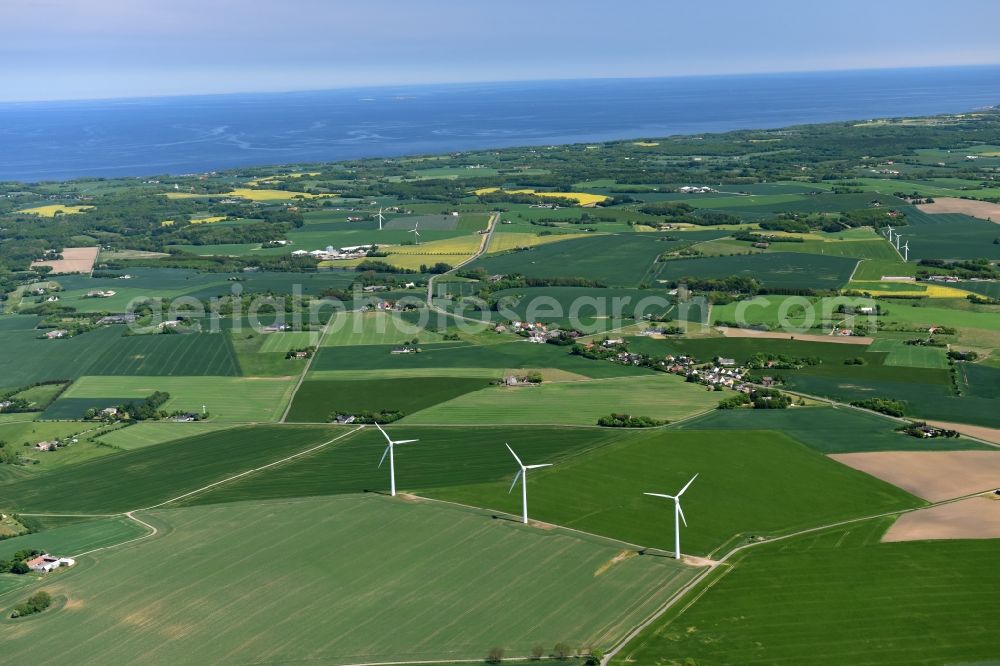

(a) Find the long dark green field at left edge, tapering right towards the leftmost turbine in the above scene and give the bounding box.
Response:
[0,426,349,514]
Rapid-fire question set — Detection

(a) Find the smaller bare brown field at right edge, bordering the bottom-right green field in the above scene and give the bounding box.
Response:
[882,497,1000,542]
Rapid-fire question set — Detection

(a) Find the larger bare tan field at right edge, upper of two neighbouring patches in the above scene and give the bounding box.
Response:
[830,451,1000,502]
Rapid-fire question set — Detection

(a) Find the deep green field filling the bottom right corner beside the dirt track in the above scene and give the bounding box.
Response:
[612,520,1000,666]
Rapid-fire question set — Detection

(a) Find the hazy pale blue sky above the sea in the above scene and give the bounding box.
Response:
[0,0,1000,101]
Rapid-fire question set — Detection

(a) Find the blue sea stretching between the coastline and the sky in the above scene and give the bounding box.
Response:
[0,66,1000,181]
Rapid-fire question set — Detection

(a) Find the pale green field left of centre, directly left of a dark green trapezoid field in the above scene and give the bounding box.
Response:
[56,377,295,421]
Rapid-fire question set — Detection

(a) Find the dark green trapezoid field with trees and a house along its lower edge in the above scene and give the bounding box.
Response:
[287,376,488,423]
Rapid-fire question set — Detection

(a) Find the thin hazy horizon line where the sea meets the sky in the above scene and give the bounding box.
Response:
[0,62,1000,107]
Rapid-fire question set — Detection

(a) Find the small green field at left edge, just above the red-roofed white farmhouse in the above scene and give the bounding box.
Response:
[0,516,149,560]
